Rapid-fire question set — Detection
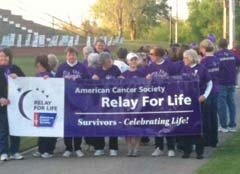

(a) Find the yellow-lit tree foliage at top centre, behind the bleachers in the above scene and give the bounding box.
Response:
[92,0,168,39]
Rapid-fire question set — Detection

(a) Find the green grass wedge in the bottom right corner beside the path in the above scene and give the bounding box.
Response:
[197,132,240,174]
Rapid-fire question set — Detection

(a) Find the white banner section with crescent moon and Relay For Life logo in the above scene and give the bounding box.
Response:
[8,77,64,137]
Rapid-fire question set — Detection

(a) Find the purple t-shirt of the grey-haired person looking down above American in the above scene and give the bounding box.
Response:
[94,65,121,79]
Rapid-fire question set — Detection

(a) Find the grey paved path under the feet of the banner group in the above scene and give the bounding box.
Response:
[0,90,240,174]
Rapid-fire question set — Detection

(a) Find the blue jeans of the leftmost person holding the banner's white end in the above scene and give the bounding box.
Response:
[0,113,20,154]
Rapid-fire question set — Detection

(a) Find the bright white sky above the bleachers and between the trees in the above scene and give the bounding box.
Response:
[0,0,188,26]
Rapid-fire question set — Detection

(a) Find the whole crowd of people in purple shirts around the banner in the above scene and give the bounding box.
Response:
[0,35,240,161]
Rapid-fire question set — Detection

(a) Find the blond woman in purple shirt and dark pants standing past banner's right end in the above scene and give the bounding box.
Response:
[200,39,219,147]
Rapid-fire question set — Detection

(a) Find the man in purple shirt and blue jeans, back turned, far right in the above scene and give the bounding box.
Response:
[215,39,240,132]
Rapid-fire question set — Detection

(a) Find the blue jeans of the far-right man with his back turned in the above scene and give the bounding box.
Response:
[218,85,237,128]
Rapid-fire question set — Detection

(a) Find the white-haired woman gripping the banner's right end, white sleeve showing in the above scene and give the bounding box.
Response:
[181,49,213,159]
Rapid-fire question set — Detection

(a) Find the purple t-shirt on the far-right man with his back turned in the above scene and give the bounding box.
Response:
[215,49,240,86]
